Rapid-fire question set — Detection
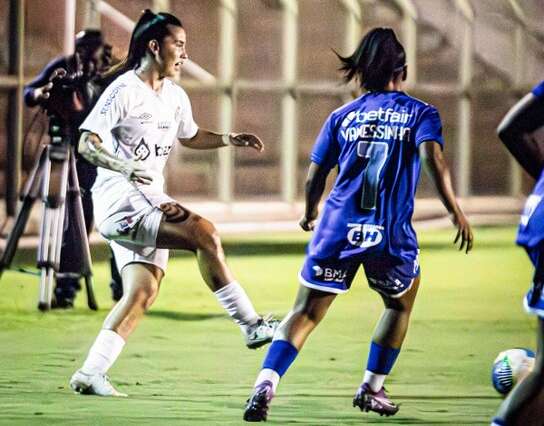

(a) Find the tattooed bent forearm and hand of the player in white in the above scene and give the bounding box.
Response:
[78,131,153,184]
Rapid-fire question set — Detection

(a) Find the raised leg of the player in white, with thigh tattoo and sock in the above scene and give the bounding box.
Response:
[156,203,278,349]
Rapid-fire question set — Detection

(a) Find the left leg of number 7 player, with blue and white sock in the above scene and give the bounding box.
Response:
[244,285,336,422]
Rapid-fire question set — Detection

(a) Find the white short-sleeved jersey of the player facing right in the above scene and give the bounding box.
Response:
[80,70,198,224]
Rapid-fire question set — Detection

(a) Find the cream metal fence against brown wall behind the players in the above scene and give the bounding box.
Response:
[0,0,544,220]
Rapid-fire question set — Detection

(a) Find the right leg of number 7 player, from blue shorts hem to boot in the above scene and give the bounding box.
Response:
[353,264,420,415]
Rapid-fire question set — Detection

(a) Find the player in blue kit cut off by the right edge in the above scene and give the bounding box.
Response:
[493,81,544,426]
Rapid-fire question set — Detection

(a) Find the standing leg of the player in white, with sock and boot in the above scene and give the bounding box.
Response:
[70,263,163,396]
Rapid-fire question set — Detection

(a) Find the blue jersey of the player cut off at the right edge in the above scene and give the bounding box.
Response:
[517,81,544,248]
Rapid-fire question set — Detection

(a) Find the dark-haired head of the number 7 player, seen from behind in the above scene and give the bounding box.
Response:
[335,28,406,90]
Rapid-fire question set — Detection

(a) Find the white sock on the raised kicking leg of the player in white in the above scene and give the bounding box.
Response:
[214,281,259,332]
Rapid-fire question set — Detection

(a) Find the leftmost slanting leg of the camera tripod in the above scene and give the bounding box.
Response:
[0,147,47,277]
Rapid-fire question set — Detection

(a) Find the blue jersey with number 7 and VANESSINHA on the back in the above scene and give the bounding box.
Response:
[308,91,443,262]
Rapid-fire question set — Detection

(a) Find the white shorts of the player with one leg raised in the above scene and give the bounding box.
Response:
[93,189,176,272]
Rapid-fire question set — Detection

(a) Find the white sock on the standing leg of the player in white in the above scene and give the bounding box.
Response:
[81,330,125,374]
